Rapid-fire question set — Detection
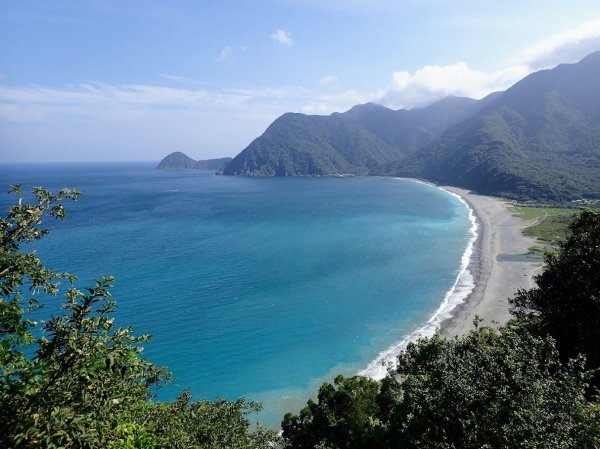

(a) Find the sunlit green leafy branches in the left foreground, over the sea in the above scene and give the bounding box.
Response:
[0,186,277,449]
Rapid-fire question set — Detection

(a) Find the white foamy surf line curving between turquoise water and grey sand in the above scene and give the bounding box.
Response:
[358,184,479,380]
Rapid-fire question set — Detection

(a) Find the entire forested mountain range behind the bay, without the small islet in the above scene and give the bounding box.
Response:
[224,52,600,202]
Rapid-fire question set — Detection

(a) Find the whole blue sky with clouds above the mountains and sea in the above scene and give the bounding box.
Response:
[0,0,600,162]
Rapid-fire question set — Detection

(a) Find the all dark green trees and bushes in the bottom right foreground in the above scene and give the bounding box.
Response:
[282,211,600,449]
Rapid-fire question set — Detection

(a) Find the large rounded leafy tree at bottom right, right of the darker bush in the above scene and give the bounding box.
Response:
[389,323,593,449]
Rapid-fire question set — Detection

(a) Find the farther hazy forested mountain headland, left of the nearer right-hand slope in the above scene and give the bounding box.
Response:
[224,97,484,176]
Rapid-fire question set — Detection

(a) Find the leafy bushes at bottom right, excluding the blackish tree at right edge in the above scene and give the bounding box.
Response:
[283,324,598,449]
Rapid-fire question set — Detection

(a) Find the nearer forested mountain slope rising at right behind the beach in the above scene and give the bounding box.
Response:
[396,52,600,201]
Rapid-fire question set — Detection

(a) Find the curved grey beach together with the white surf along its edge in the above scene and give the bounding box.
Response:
[358,178,540,380]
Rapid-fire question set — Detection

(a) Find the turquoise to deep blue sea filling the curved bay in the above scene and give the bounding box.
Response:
[0,163,470,425]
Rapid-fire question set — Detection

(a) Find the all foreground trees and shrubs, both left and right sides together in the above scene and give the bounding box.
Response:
[0,187,600,449]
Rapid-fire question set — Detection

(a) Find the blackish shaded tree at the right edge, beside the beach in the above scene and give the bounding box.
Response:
[511,210,600,374]
